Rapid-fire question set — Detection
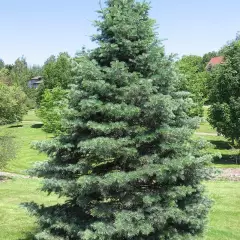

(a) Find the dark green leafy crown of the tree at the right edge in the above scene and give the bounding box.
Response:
[209,40,240,143]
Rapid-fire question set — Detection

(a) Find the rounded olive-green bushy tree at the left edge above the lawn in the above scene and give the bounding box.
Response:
[0,84,27,125]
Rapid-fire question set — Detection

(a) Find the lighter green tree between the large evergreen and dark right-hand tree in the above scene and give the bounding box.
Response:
[177,55,208,116]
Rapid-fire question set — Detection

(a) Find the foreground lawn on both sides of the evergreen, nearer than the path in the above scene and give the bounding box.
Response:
[0,179,240,240]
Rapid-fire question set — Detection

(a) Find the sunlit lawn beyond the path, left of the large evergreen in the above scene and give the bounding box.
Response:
[1,111,51,174]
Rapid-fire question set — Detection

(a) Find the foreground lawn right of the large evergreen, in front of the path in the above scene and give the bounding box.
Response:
[206,181,240,240]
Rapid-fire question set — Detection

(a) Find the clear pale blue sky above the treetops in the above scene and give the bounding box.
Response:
[0,0,240,64]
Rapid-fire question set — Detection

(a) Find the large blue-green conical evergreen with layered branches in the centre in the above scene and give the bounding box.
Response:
[28,0,211,240]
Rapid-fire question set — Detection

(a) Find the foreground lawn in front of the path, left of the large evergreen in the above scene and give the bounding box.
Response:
[0,179,59,240]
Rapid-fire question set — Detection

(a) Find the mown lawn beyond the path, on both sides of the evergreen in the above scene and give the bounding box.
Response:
[3,108,240,174]
